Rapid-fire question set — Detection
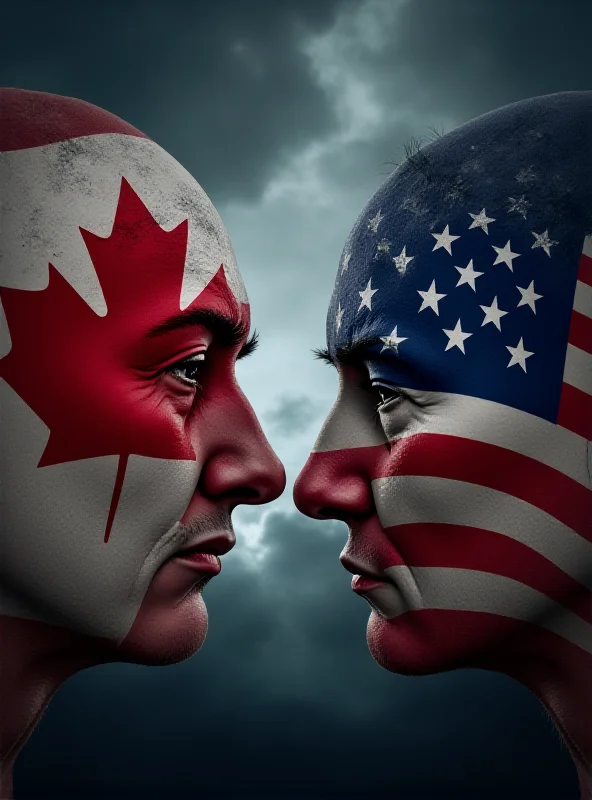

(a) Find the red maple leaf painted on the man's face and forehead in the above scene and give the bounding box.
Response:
[0,178,246,541]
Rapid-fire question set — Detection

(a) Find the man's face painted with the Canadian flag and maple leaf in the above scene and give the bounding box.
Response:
[0,89,284,661]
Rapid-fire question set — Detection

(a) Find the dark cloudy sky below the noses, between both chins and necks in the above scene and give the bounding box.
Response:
[16,512,578,800]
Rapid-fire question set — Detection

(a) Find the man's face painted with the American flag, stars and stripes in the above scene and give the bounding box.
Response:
[294,131,592,674]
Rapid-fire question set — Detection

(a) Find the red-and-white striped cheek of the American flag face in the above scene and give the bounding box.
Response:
[369,434,592,668]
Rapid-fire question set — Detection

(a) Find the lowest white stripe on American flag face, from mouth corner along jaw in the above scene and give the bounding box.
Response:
[385,567,592,654]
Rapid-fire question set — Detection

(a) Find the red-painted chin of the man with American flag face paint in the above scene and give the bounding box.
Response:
[366,609,518,675]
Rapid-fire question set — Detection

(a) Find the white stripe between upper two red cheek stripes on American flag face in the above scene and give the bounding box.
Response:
[372,475,592,589]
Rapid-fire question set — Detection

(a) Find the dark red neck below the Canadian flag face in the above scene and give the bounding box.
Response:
[0,616,106,800]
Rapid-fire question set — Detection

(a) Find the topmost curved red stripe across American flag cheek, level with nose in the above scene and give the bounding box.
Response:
[380,433,592,541]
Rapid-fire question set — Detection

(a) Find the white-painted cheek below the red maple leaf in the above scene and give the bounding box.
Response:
[0,384,200,641]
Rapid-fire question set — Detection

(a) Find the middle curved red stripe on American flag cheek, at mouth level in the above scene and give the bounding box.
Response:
[385,520,592,623]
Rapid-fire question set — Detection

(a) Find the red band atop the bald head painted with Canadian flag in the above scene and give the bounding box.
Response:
[0,88,148,151]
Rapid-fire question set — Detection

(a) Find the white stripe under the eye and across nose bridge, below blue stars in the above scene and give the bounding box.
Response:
[314,388,590,487]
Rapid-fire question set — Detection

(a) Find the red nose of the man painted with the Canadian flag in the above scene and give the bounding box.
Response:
[198,390,286,509]
